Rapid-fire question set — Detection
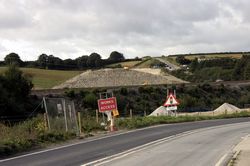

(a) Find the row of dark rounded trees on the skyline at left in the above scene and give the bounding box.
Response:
[2,51,125,70]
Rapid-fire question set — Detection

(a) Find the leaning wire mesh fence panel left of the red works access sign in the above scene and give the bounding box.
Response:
[43,98,79,133]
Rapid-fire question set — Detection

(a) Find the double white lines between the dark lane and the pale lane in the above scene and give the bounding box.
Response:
[81,122,249,166]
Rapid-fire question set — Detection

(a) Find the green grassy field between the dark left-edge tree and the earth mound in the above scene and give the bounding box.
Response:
[0,67,82,89]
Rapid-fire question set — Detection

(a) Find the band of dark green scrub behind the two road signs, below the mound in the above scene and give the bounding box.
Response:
[65,84,250,117]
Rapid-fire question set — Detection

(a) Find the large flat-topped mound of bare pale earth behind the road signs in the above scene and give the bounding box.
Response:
[53,69,186,89]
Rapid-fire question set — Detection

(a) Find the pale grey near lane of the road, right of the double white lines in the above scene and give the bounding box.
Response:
[98,122,250,166]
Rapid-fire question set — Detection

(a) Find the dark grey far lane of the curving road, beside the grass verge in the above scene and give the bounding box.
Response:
[0,118,250,166]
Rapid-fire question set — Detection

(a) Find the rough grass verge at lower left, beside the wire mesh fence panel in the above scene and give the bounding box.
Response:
[0,116,76,158]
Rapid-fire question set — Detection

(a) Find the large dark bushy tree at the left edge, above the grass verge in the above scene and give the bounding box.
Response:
[0,65,33,117]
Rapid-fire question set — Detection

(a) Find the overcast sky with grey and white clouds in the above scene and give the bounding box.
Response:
[0,0,250,60]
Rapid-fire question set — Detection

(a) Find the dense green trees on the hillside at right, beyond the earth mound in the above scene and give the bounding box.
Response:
[172,54,250,82]
